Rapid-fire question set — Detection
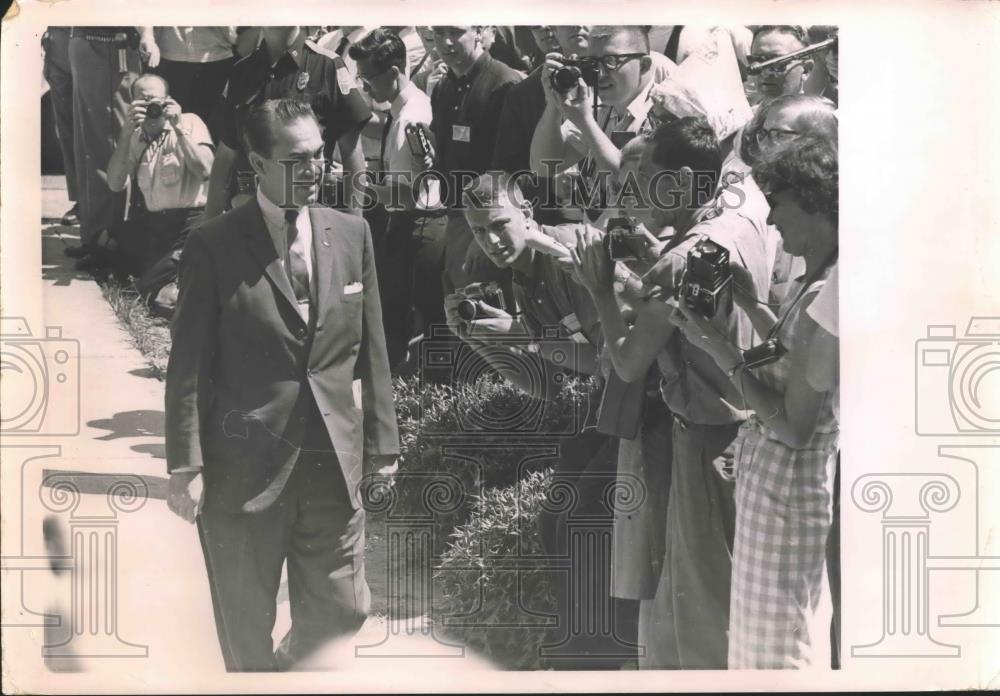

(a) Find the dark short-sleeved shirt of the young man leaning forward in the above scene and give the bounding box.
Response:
[511,239,601,348]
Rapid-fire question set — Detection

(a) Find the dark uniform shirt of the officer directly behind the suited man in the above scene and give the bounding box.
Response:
[213,37,371,193]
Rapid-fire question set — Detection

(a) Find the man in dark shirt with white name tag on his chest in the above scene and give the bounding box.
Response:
[431,26,521,291]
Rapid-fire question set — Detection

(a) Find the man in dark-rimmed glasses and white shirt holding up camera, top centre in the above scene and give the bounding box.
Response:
[531,26,676,220]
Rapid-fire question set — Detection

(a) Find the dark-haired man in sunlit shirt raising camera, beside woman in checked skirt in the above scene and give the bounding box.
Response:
[576,117,769,669]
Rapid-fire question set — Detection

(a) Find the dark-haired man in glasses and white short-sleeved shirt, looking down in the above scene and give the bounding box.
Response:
[350,29,446,368]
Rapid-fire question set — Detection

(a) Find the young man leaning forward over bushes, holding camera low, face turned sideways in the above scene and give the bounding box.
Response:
[445,172,638,669]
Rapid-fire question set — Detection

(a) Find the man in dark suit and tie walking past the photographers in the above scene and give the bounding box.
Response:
[166,99,399,671]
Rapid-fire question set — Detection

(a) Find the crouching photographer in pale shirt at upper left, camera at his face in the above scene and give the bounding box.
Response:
[108,73,214,276]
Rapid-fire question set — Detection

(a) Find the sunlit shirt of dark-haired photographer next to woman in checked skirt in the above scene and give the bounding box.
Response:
[657,185,771,425]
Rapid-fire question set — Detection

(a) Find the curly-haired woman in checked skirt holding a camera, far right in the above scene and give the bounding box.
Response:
[671,137,839,669]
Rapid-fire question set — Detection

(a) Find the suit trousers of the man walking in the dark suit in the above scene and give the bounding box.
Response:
[198,436,371,672]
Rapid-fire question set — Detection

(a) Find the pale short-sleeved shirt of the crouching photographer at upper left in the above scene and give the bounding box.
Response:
[129,114,212,211]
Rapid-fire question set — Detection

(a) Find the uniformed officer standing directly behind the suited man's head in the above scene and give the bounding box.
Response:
[205,27,371,219]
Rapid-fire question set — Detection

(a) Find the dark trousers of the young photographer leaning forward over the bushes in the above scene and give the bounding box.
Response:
[538,430,639,670]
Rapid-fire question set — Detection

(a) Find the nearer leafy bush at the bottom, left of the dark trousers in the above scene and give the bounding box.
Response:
[434,470,555,669]
